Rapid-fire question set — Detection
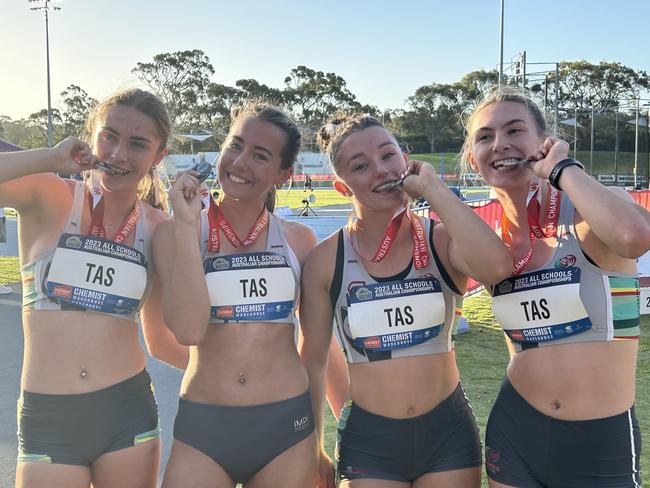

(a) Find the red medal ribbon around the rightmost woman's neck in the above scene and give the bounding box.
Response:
[501,183,562,276]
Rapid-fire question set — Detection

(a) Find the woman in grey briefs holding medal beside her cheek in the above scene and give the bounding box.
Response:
[155,104,317,488]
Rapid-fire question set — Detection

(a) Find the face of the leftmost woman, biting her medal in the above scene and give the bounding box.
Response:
[93,105,165,191]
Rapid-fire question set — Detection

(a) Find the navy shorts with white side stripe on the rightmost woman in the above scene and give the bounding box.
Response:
[485,378,641,488]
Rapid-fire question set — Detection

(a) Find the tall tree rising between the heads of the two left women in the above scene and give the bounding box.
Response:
[131,49,214,129]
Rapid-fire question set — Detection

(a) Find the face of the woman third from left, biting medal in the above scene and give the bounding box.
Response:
[336,126,407,210]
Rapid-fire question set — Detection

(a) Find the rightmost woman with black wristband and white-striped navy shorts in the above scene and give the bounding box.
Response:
[465,90,650,488]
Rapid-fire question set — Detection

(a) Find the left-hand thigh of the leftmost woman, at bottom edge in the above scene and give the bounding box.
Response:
[16,461,90,488]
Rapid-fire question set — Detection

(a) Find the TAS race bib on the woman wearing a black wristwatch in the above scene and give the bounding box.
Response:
[492,267,591,342]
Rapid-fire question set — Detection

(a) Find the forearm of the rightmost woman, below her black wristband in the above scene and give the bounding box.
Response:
[559,166,650,258]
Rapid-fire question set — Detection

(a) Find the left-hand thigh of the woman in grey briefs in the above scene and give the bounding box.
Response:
[162,439,235,488]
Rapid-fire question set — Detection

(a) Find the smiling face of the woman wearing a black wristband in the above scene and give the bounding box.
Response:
[469,101,545,188]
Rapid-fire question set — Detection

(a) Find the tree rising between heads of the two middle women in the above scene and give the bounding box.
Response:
[284,66,360,129]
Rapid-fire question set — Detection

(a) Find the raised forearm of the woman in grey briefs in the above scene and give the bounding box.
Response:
[163,222,210,345]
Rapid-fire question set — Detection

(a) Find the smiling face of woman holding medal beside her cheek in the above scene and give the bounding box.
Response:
[218,117,292,200]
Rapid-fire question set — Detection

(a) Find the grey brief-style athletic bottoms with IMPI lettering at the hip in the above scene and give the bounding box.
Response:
[174,390,314,483]
